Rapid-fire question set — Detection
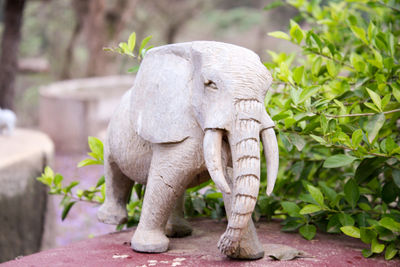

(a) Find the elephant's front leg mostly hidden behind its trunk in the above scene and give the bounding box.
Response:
[223,168,264,260]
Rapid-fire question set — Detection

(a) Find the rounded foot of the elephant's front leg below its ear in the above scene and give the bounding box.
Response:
[131,229,169,253]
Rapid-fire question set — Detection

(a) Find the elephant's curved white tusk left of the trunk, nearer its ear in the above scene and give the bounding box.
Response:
[203,129,231,194]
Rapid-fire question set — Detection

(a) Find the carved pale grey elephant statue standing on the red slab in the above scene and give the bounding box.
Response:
[97,41,279,259]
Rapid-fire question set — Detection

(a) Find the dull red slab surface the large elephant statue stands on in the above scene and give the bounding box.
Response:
[2,219,400,267]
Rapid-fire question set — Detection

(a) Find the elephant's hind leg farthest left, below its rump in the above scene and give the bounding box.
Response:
[97,157,134,224]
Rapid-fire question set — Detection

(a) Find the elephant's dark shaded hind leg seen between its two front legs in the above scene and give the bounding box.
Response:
[165,193,193,237]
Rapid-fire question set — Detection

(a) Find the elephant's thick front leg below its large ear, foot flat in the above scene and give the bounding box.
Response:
[131,138,202,253]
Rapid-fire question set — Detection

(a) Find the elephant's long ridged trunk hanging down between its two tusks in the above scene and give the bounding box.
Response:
[218,114,260,257]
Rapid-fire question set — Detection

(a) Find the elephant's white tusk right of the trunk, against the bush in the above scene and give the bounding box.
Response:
[261,127,279,196]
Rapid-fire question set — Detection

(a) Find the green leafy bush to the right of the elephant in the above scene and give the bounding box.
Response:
[261,0,400,259]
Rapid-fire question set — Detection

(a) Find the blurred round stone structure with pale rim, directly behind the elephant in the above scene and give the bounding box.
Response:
[39,75,134,152]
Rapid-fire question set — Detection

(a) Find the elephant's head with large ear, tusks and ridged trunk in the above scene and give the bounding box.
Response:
[132,41,279,254]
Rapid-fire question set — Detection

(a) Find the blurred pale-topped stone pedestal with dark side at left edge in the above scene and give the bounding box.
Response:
[0,129,53,262]
